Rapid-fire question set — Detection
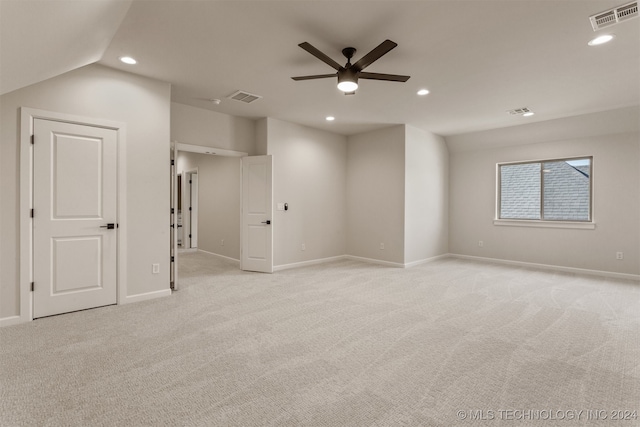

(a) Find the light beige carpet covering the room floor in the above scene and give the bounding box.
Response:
[0,253,640,426]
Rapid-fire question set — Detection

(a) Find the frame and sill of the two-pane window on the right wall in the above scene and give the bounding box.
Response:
[494,156,595,229]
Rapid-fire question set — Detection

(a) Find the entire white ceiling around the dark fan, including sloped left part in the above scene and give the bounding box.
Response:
[0,0,640,136]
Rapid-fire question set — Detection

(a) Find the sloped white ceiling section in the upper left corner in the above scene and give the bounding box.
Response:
[0,0,131,94]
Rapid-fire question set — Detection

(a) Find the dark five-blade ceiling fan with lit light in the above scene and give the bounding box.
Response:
[291,40,409,95]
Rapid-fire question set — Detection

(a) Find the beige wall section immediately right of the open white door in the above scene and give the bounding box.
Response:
[258,118,347,267]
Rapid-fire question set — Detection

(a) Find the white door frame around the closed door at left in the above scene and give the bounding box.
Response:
[15,107,127,323]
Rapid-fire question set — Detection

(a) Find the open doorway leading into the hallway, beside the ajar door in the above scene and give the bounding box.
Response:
[171,142,247,290]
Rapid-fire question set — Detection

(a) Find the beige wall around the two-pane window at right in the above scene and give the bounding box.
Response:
[448,117,640,275]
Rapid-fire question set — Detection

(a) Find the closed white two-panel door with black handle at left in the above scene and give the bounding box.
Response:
[33,119,118,318]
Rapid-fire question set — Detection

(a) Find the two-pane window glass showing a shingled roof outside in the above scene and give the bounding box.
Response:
[498,157,593,221]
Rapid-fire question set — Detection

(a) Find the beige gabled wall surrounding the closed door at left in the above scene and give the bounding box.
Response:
[0,65,171,319]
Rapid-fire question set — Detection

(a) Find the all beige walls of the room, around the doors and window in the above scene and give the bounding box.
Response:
[5,65,640,319]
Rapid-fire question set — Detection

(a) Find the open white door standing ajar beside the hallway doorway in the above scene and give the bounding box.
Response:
[240,156,273,273]
